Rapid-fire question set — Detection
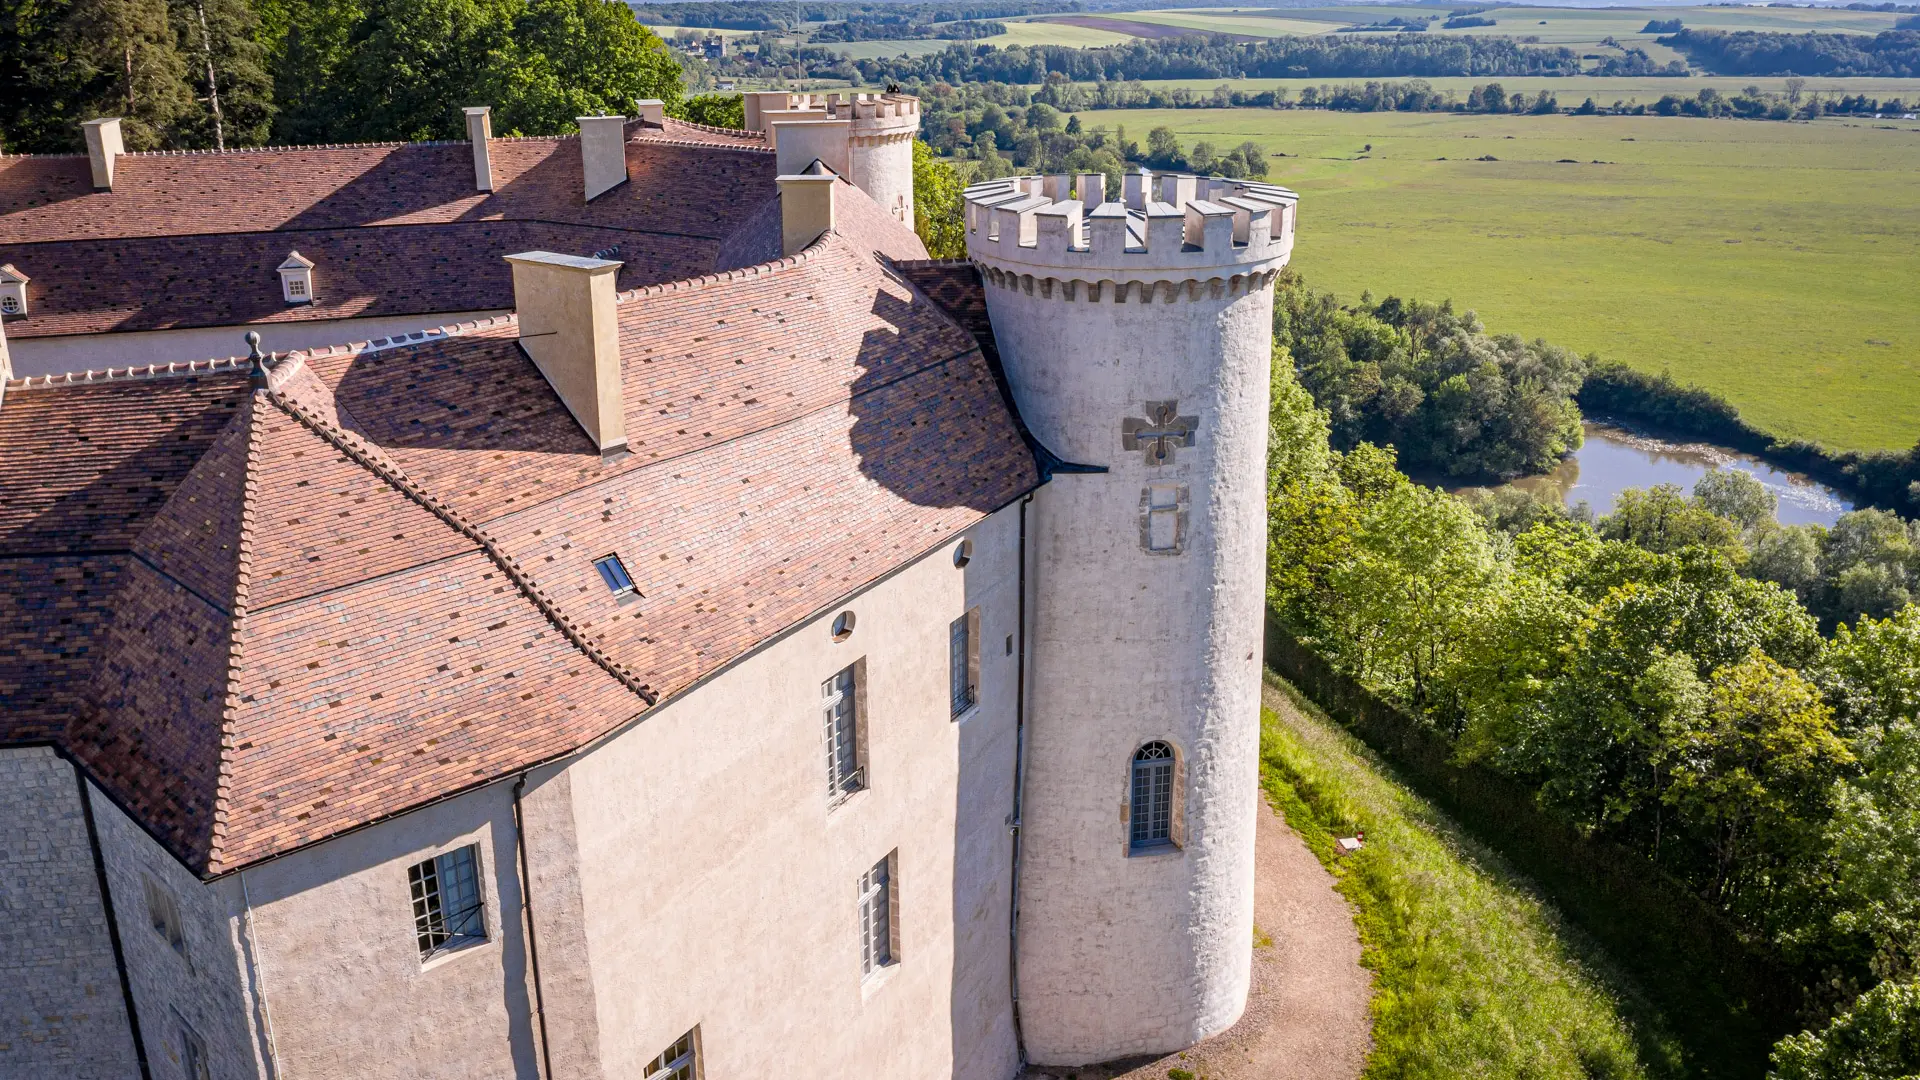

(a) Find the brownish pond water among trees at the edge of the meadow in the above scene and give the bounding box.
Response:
[1459,423,1853,525]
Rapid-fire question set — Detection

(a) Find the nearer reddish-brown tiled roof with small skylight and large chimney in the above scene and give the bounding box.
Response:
[0,226,1039,876]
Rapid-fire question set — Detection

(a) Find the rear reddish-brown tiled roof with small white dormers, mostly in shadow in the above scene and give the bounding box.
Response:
[0,121,774,338]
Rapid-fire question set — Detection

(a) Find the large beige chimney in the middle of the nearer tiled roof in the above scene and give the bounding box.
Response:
[507,249,626,457]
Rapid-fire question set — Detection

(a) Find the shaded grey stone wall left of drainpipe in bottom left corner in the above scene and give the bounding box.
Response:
[0,748,140,1080]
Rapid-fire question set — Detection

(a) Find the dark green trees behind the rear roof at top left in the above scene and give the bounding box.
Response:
[0,0,682,152]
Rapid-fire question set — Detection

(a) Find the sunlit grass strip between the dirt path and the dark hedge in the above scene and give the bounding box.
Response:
[1261,675,1682,1080]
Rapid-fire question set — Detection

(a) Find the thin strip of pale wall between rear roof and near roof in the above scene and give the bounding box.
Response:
[8,311,505,379]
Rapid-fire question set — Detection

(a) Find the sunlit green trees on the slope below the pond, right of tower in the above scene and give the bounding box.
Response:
[1269,334,1920,1078]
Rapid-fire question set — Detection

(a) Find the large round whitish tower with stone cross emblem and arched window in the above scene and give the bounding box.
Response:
[966,171,1296,1065]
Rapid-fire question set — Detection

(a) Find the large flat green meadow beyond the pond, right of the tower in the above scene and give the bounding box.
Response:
[1081,110,1920,450]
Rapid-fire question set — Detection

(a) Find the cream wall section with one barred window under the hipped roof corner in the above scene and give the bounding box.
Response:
[246,782,538,1080]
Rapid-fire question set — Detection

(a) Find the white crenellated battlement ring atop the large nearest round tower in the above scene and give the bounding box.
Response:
[964,169,1300,281]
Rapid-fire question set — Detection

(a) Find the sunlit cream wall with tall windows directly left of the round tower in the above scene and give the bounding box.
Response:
[560,507,1020,1080]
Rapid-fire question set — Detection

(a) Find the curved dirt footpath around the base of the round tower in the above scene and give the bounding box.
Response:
[1021,801,1373,1080]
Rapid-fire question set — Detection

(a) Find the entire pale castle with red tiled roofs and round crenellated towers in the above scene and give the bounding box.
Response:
[0,92,1296,1080]
